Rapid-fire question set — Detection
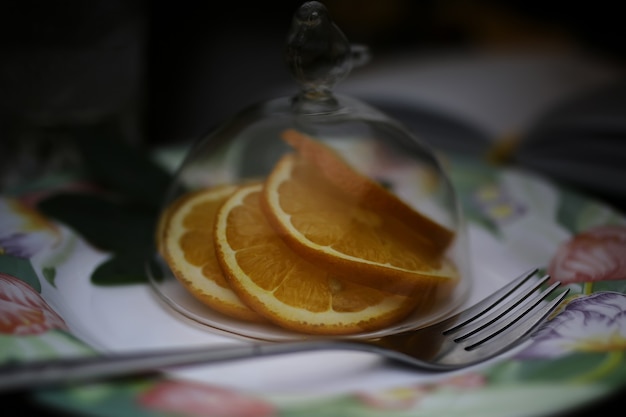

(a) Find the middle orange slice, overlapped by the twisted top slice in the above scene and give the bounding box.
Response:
[215,184,415,335]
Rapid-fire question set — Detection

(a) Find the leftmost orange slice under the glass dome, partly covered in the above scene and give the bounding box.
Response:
[157,186,266,322]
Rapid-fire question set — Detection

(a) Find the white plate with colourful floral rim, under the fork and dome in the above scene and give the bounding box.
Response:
[0,148,626,417]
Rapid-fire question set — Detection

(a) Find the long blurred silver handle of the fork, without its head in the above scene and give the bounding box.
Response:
[0,340,346,392]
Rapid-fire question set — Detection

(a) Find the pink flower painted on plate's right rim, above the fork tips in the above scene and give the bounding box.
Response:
[548,225,626,284]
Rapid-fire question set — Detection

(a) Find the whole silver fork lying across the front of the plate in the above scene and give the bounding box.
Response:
[0,269,568,391]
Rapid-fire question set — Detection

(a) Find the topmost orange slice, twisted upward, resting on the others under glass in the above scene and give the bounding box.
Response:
[261,130,459,296]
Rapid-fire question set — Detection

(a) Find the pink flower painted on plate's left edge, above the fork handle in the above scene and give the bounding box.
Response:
[0,272,67,335]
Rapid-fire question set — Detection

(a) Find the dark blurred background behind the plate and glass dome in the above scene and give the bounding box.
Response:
[0,0,626,207]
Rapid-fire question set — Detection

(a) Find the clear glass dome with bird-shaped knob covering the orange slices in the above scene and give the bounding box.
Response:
[149,1,471,341]
